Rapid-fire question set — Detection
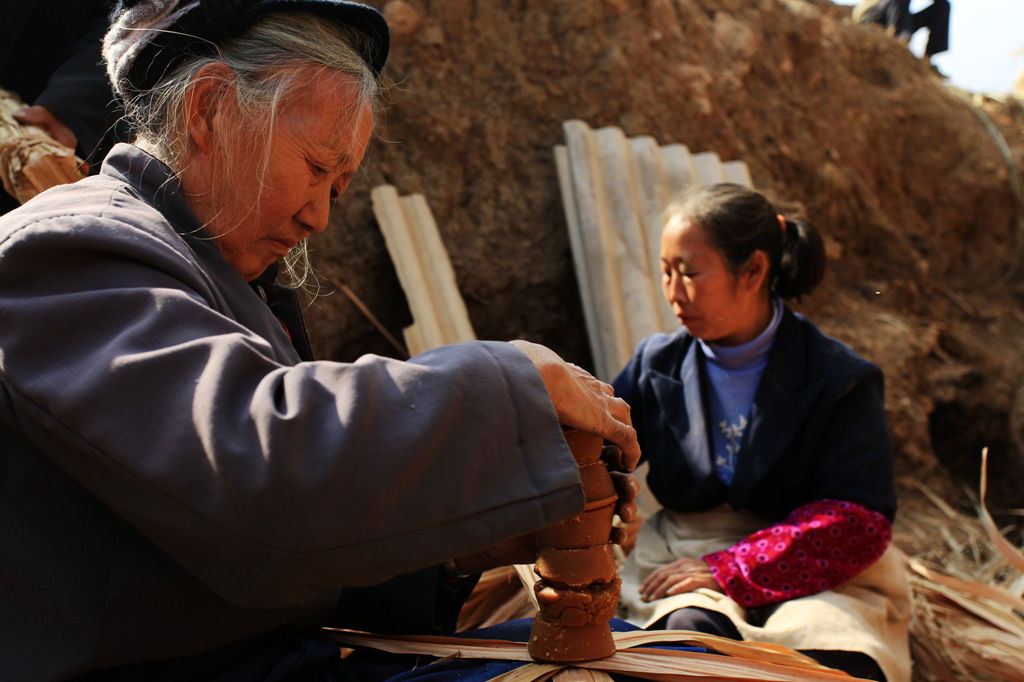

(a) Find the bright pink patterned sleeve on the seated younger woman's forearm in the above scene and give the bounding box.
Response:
[701,493,892,607]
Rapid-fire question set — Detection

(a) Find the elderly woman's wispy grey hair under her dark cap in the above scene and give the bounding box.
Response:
[104,0,381,286]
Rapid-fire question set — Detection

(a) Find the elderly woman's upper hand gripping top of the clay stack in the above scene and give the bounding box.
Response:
[510,340,640,471]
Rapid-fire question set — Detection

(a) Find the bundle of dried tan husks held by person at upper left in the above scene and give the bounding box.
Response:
[0,88,84,204]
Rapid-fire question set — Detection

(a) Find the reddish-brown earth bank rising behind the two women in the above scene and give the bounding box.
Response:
[308,0,1024,544]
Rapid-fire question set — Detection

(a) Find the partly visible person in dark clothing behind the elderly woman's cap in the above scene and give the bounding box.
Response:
[0,0,126,213]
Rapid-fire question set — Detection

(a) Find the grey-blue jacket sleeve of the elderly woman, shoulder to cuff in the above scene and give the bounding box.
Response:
[0,206,584,607]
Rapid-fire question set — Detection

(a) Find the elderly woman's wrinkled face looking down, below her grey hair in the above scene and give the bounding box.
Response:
[197,77,373,281]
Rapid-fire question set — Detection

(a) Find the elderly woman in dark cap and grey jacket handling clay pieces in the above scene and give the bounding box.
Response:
[0,0,639,680]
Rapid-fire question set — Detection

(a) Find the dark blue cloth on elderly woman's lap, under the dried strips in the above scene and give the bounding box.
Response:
[336,619,707,682]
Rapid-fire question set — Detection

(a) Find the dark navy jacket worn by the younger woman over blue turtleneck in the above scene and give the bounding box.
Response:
[612,308,896,520]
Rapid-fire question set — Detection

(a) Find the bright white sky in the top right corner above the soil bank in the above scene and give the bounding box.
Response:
[833,0,1024,94]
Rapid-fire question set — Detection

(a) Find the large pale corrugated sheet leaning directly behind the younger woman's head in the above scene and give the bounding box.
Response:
[554,120,751,381]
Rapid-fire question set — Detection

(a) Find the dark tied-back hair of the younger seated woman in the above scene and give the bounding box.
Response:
[666,182,825,301]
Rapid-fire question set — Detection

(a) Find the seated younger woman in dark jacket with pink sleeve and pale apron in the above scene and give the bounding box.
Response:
[612,183,910,682]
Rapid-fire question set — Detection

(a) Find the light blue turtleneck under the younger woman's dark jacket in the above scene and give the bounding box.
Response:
[697,298,782,485]
